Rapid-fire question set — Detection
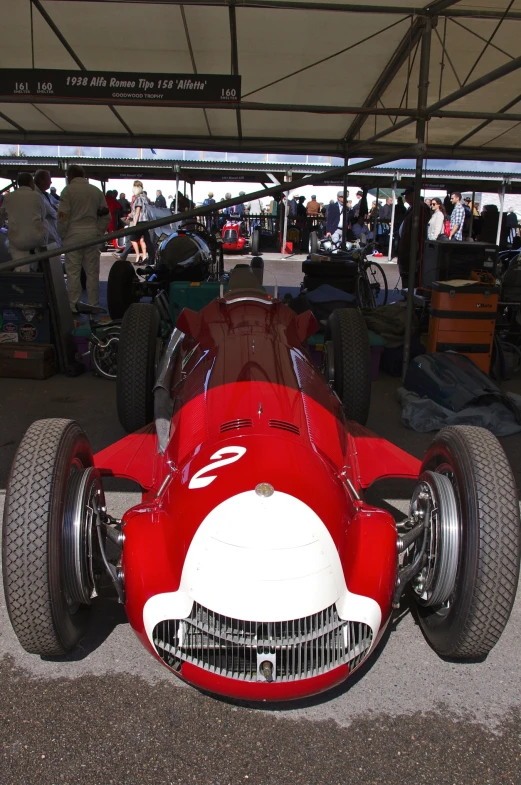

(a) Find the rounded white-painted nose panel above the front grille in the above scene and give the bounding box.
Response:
[180,490,345,622]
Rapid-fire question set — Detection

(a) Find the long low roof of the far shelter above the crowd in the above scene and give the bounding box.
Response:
[4,156,521,194]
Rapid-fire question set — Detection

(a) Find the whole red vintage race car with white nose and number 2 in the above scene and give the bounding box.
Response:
[3,269,519,701]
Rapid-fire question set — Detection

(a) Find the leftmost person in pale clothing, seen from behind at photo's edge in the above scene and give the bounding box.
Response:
[3,172,46,273]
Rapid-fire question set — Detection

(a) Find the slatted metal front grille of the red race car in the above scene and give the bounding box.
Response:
[153,603,373,682]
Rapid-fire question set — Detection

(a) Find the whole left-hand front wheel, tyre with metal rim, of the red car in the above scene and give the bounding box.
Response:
[2,419,98,657]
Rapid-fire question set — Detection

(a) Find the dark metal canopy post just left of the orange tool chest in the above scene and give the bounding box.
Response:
[402,17,432,378]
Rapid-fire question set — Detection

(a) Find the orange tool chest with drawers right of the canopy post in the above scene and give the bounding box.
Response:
[427,281,499,373]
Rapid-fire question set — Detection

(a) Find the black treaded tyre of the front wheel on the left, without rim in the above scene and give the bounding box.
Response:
[2,419,93,657]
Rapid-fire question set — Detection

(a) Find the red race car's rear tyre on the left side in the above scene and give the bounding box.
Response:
[116,303,160,433]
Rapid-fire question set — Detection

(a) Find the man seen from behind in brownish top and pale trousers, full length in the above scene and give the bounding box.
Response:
[58,164,110,313]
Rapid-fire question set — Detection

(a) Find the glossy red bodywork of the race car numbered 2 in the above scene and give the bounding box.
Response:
[95,295,420,700]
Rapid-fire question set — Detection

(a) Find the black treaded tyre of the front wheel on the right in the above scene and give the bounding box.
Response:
[417,425,520,660]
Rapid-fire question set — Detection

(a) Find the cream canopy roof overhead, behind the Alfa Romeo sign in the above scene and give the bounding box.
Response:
[0,0,521,161]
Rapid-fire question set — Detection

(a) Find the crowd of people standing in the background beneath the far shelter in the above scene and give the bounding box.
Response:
[0,171,521,312]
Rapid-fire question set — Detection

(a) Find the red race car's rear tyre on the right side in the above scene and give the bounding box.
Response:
[325,308,371,425]
